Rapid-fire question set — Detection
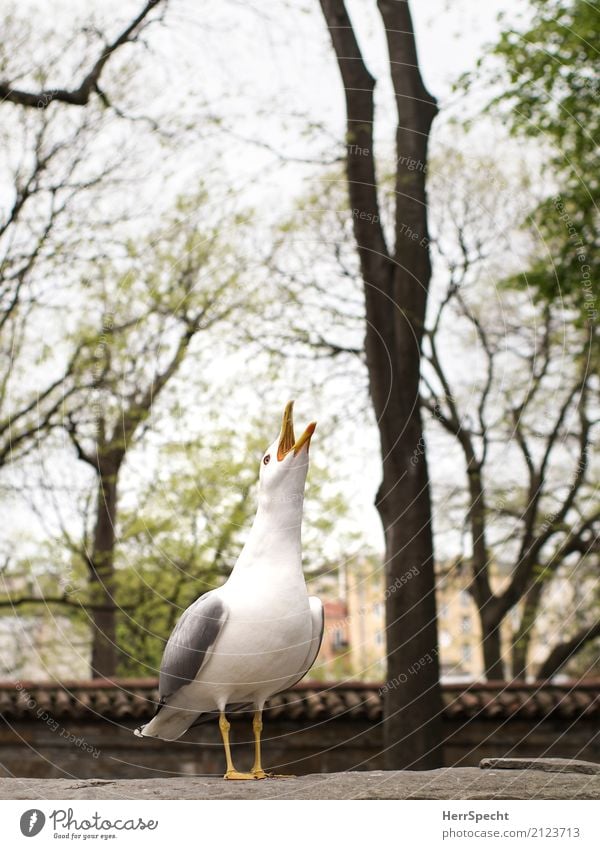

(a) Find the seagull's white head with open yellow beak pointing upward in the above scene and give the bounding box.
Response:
[259,401,317,510]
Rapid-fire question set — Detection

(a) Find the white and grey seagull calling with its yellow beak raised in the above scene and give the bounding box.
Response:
[135,401,323,779]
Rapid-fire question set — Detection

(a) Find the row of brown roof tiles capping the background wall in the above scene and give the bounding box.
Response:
[0,678,600,721]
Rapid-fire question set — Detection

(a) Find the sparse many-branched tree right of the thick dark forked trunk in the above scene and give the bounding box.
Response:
[422,152,600,679]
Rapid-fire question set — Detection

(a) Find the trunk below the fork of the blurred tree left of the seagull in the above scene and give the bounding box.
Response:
[89,460,119,678]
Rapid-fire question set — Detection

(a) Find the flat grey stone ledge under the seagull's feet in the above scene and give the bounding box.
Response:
[0,767,600,799]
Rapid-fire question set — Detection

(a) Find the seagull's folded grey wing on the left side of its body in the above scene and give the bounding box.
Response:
[159,591,228,702]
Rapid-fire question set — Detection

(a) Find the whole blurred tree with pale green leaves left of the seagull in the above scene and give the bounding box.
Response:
[57,193,252,677]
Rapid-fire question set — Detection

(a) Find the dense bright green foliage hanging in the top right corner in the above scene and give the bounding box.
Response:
[468,0,600,312]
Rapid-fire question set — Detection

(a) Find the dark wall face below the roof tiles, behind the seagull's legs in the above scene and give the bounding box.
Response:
[0,717,600,779]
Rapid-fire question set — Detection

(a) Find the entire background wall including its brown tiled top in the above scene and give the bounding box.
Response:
[0,679,600,779]
